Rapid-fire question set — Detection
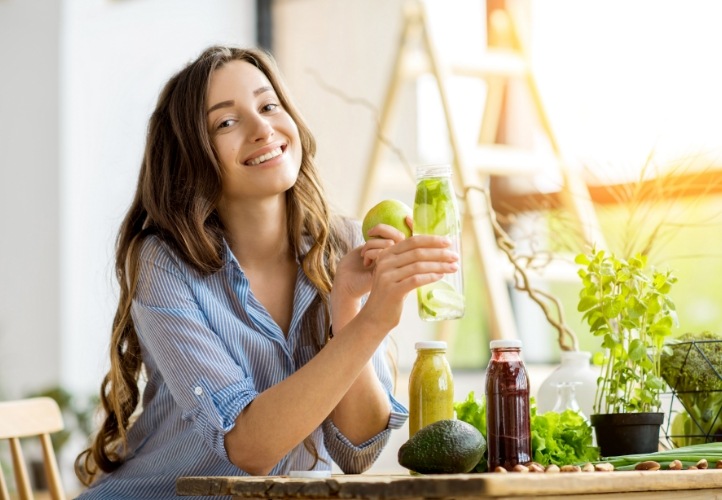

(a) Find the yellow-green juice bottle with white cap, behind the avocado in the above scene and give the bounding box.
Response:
[409,341,454,437]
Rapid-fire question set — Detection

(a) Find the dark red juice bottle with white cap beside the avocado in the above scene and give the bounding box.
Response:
[486,340,531,471]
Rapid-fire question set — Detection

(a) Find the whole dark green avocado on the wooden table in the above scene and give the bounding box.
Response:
[398,419,486,474]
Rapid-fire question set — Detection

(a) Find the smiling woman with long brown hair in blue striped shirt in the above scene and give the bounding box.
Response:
[76,47,458,499]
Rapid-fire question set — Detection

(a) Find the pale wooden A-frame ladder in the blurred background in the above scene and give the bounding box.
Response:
[359,0,603,339]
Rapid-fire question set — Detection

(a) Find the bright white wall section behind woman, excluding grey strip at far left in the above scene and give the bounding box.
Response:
[60,0,255,398]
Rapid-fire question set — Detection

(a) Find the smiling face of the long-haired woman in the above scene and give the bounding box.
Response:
[206,61,302,203]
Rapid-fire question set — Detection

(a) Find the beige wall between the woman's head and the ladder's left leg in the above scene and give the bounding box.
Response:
[273,0,414,216]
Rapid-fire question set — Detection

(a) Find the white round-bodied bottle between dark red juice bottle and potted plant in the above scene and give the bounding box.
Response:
[536,351,599,417]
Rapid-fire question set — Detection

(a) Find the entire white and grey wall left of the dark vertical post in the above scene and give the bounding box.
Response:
[0,0,255,397]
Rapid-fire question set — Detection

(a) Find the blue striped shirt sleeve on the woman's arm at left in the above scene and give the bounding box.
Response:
[132,238,257,460]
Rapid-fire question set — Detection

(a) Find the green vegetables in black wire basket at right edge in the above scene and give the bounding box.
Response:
[662,331,722,446]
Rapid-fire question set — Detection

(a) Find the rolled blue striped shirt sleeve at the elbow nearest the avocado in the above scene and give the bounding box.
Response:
[323,339,409,474]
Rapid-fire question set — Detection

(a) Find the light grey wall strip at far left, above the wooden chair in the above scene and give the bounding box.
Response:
[0,0,60,396]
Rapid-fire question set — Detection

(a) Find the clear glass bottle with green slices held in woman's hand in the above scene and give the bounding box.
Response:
[414,165,465,321]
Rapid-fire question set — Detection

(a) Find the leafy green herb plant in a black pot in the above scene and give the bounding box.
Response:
[575,249,677,456]
